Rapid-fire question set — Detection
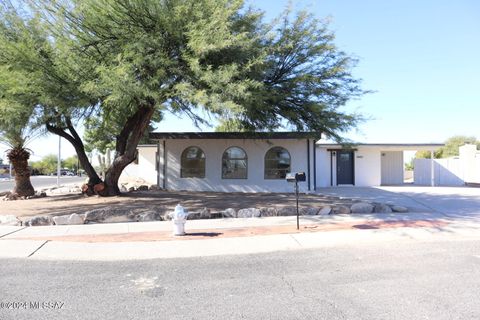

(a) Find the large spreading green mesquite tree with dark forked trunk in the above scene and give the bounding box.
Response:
[1,0,363,195]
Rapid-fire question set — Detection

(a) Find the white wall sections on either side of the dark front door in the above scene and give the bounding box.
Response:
[317,147,381,187]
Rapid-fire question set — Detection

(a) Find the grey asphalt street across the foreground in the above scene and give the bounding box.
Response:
[0,238,480,320]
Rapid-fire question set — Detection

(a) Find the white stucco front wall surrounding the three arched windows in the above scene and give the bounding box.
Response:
[160,139,312,192]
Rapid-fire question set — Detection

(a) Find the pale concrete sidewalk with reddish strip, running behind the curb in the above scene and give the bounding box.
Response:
[0,213,480,260]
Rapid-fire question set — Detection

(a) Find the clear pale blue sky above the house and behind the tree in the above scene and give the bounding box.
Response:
[0,0,480,159]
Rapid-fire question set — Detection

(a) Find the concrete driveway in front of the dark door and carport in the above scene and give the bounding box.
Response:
[317,186,480,219]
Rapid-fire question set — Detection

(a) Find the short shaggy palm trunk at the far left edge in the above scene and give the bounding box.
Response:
[7,147,35,197]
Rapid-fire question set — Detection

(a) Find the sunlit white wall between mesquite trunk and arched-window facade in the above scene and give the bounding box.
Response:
[120,146,157,184]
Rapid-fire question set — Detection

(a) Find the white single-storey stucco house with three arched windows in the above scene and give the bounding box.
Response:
[121,132,443,192]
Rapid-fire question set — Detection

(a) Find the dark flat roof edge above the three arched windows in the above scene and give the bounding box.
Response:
[149,132,321,140]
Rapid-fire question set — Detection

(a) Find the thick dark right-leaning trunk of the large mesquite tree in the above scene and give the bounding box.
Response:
[99,101,155,196]
